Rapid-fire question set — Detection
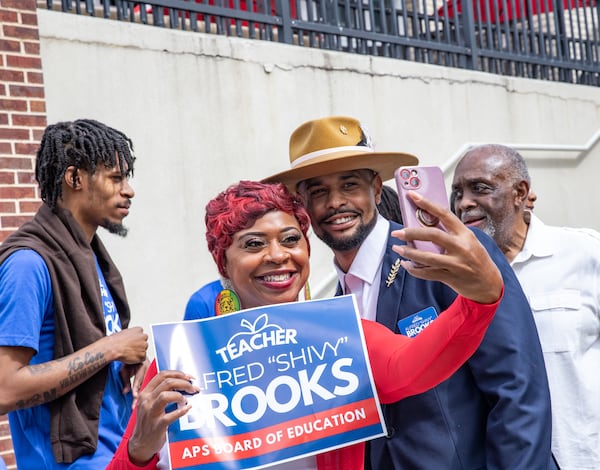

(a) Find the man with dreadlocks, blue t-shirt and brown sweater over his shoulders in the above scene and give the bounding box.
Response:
[0,119,148,469]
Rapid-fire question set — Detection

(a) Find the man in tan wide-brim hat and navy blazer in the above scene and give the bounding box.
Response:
[264,116,556,470]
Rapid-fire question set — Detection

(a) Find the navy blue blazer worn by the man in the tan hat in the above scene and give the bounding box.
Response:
[354,222,556,470]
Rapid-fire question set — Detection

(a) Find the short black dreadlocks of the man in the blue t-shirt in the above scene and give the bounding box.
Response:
[35,119,135,209]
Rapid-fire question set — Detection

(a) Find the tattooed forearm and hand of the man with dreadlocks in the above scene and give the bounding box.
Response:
[0,327,148,414]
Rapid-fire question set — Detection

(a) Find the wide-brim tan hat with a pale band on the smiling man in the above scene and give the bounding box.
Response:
[263,116,419,191]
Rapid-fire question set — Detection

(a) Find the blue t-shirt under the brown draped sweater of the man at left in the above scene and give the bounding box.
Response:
[0,250,133,470]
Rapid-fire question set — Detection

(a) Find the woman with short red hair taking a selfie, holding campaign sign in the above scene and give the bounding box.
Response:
[108,181,503,470]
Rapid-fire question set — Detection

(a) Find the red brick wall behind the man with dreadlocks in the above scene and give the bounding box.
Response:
[0,0,46,469]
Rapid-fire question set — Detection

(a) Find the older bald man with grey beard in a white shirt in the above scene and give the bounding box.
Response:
[452,145,600,470]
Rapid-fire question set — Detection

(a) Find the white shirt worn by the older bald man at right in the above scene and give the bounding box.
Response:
[511,214,600,470]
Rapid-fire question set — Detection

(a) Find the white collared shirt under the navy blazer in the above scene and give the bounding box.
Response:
[333,214,390,321]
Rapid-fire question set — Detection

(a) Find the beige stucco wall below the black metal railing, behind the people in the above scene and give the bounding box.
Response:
[39,10,600,336]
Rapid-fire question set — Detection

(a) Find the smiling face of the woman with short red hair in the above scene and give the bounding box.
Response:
[225,210,310,308]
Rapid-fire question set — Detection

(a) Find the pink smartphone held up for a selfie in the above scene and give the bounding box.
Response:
[394,166,449,253]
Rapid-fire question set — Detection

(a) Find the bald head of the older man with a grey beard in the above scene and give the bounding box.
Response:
[451,144,530,252]
